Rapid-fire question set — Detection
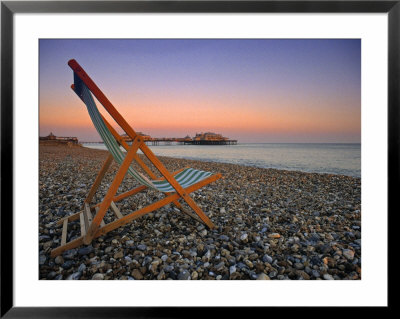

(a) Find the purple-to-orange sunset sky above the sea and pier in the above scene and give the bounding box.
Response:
[39,39,361,143]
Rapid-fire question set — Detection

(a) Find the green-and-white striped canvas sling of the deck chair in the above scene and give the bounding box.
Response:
[74,73,213,193]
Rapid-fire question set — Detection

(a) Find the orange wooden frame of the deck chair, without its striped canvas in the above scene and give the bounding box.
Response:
[51,59,222,257]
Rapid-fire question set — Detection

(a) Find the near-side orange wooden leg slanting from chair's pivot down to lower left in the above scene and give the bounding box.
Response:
[83,137,142,245]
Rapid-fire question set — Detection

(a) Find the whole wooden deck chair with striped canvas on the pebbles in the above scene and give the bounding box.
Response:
[51,60,221,257]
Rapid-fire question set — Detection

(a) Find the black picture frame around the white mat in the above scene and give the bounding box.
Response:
[0,0,394,318]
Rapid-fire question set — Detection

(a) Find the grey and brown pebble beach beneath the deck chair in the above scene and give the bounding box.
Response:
[38,144,361,280]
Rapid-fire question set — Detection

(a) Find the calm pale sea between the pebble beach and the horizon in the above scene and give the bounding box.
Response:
[83,143,361,177]
